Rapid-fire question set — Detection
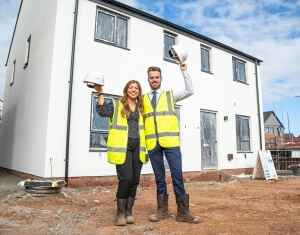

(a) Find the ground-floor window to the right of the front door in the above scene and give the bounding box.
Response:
[236,116,251,151]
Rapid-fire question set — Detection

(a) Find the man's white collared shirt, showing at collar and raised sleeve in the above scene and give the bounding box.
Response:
[148,71,194,103]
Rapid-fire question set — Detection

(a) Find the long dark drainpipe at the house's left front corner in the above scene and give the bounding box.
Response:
[65,0,79,186]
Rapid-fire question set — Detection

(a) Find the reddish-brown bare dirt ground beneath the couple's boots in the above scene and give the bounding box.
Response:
[0,176,300,235]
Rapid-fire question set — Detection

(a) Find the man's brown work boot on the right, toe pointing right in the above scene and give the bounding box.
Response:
[176,194,200,224]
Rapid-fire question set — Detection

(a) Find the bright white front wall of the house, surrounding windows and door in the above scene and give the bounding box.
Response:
[69,1,264,177]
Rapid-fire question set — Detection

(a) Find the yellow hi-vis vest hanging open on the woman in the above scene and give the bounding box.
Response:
[107,100,146,165]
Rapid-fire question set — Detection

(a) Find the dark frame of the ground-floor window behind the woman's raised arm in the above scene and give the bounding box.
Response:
[89,92,120,152]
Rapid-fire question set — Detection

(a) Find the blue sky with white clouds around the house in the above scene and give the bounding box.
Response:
[0,0,300,136]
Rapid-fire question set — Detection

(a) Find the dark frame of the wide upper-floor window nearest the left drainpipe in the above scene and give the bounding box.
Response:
[94,7,130,49]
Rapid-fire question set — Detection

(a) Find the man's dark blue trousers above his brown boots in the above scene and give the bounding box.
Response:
[148,142,186,195]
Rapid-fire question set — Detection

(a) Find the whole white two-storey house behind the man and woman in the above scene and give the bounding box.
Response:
[0,0,265,187]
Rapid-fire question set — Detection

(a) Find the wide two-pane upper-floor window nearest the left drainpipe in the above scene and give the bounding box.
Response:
[95,8,128,48]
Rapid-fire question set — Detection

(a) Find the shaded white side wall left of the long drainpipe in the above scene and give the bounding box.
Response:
[0,0,75,177]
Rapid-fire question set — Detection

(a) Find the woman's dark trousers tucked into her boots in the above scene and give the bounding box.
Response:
[116,138,143,199]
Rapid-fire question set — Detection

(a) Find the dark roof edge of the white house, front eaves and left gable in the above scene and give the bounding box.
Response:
[5,0,263,66]
